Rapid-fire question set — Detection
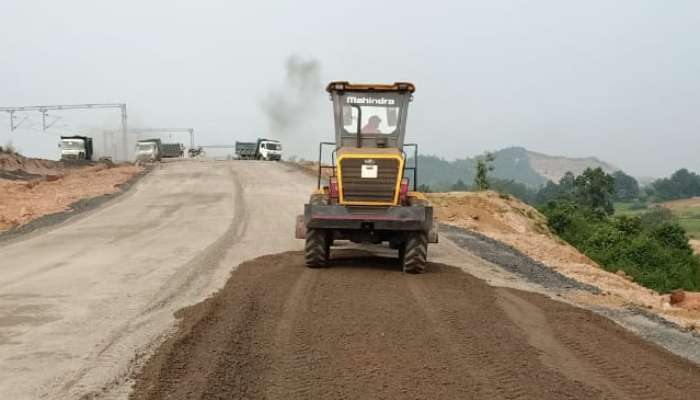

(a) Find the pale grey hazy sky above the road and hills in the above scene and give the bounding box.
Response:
[0,0,700,176]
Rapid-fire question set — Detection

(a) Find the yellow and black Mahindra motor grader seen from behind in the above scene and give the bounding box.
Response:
[296,82,438,273]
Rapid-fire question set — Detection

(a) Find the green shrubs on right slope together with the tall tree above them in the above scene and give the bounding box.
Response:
[539,168,700,292]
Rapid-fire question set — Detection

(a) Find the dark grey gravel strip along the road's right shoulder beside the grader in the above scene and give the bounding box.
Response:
[440,224,600,293]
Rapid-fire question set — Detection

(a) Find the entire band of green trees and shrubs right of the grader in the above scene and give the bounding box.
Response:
[422,154,700,292]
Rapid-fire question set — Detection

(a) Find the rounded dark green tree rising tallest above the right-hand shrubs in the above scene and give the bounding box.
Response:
[574,167,615,215]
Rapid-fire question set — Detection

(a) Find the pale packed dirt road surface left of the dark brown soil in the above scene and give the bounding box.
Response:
[0,162,314,399]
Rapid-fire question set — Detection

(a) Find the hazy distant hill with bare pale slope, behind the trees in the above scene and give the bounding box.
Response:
[416,147,618,190]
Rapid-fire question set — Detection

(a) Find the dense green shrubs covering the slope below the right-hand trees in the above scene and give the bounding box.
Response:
[542,201,700,293]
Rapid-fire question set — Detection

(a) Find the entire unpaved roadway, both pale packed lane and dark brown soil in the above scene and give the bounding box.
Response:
[0,160,700,399]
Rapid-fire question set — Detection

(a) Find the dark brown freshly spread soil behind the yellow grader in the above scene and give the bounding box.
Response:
[131,250,700,399]
